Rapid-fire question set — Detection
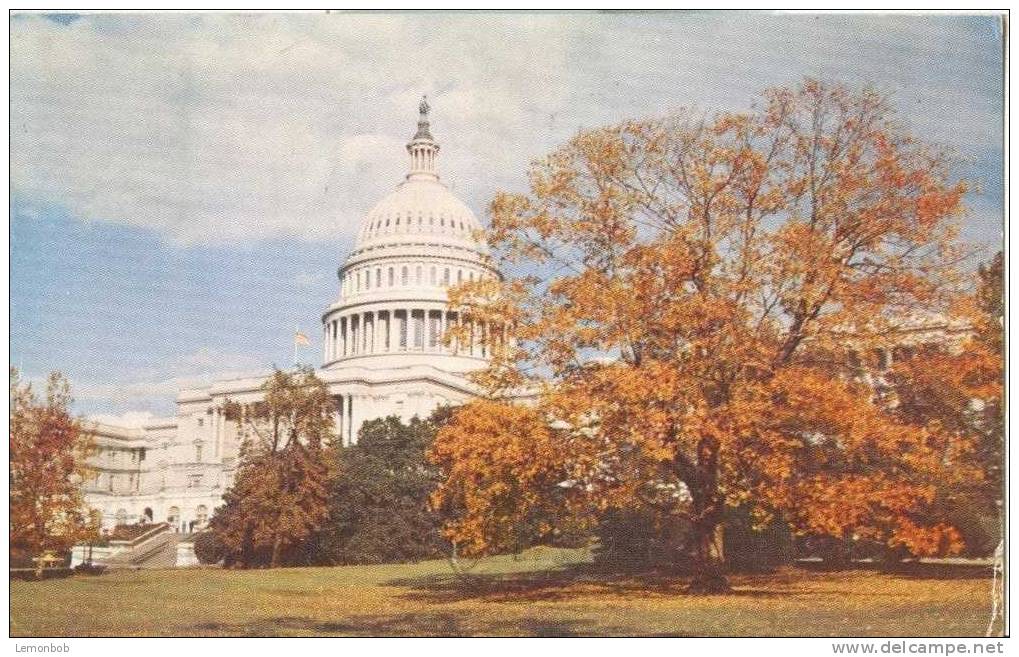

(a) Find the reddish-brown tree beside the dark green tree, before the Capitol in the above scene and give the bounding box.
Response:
[210,368,333,567]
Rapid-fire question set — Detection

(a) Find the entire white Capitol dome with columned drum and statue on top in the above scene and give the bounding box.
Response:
[322,100,500,373]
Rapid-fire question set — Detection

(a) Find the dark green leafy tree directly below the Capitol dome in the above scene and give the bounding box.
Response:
[307,408,449,564]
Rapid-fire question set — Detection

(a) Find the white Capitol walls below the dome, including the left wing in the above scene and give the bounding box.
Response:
[86,366,473,532]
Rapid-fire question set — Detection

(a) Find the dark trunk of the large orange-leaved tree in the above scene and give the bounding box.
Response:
[689,436,730,593]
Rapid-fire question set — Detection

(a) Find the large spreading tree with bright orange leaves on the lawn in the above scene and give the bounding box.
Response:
[434,79,986,591]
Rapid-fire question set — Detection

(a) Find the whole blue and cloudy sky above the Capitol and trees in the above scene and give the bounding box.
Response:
[10,12,1002,419]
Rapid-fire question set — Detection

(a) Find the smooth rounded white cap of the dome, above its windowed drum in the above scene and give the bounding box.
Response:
[356,177,488,253]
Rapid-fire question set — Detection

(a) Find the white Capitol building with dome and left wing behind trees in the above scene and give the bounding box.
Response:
[86,100,500,532]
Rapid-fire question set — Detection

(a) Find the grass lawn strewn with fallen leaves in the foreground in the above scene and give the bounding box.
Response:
[10,548,990,637]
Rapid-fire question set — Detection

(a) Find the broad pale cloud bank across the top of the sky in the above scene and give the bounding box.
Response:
[11,13,1000,248]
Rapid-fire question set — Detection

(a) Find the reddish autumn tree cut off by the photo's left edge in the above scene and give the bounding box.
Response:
[9,368,97,554]
